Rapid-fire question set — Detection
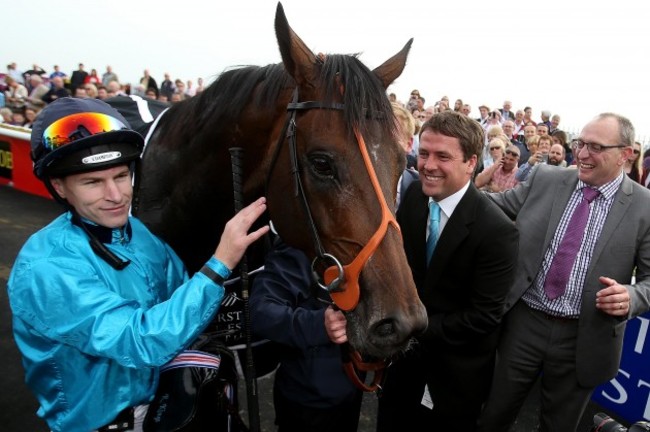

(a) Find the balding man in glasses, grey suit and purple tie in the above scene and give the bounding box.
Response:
[479,113,650,432]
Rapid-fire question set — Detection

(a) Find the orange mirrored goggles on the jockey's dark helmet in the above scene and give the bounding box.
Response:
[43,113,126,150]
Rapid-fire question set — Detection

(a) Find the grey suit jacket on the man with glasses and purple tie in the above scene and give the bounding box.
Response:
[490,165,650,387]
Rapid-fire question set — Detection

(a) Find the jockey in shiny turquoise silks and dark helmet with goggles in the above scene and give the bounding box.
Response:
[7,98,268,432]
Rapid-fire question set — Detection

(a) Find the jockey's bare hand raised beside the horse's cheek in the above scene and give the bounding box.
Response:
[214,198,269,270]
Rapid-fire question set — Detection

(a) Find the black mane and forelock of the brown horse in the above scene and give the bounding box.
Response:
[163,54,395,140]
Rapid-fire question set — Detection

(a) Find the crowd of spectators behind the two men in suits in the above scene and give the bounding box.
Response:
[389,89,650,192]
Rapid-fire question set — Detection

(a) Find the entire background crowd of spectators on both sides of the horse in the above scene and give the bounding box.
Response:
[0,63,650,192]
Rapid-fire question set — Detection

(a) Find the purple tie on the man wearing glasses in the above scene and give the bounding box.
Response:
[544,187,600,300]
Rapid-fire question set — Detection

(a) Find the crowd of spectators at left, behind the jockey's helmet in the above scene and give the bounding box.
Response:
[0,63,204,128]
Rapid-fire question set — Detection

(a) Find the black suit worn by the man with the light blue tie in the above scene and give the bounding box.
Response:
[378,180,518,430]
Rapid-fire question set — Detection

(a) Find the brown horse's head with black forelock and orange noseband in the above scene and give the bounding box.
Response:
[267,5,427,358]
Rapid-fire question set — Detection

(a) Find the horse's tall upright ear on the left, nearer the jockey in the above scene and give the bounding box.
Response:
[275,2,317,86]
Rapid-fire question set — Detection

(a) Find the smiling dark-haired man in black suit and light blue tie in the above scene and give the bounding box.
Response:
[377,111,518,432]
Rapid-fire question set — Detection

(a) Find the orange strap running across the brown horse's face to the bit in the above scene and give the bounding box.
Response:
[323,129,401,312]
